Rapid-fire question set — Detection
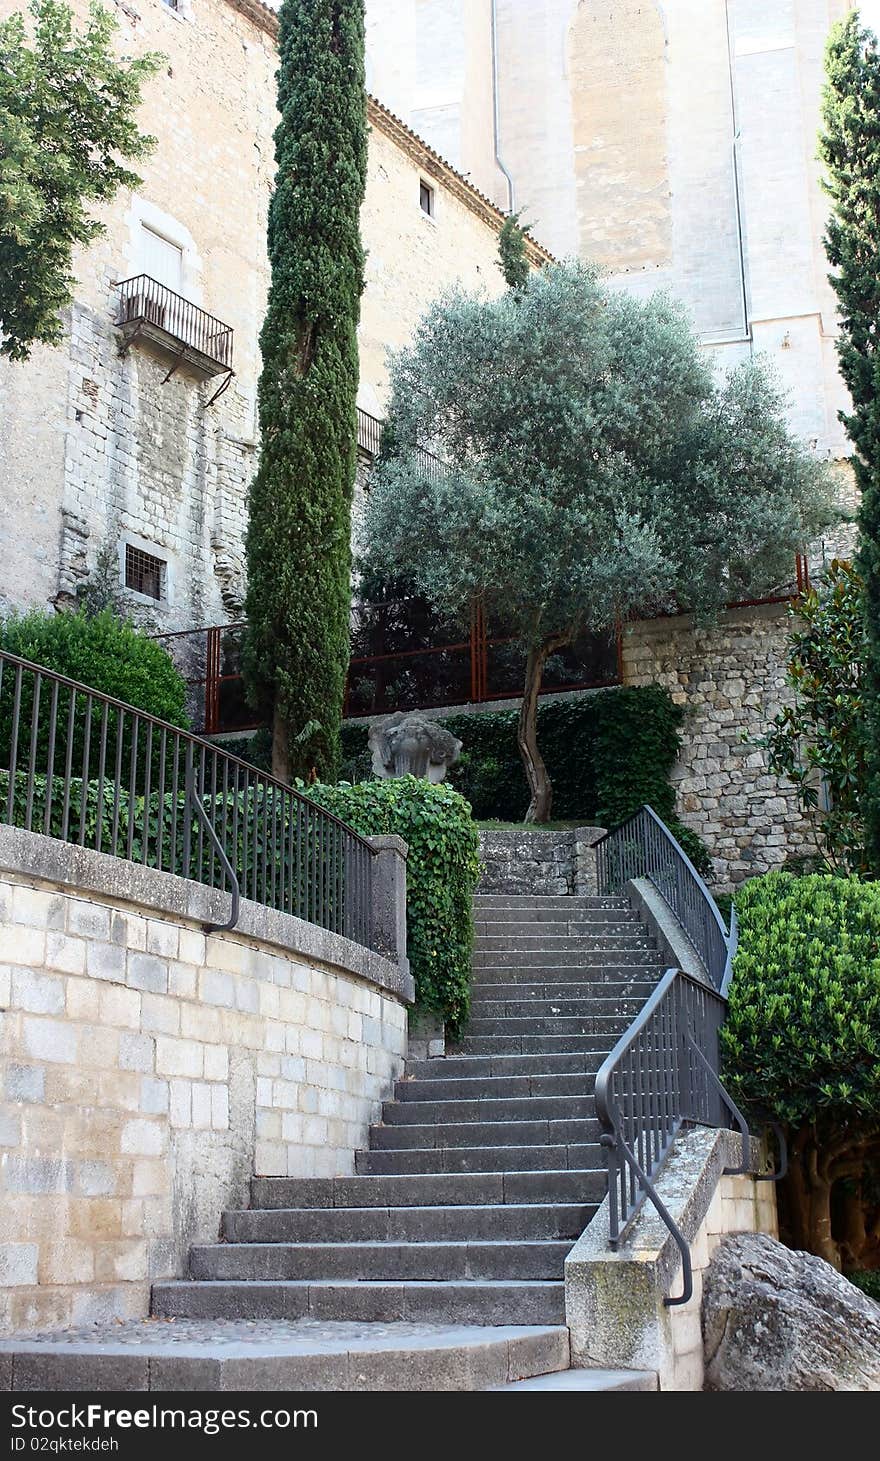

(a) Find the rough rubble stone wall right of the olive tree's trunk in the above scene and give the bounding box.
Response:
[623,603,816,887]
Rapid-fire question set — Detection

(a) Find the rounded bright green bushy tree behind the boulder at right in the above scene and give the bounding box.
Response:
[721,872,880,1270]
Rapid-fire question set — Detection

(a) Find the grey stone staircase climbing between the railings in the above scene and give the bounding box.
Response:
[0,893,661,1389]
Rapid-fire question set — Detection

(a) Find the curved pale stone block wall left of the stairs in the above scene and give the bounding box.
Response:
[0,828,411,1332]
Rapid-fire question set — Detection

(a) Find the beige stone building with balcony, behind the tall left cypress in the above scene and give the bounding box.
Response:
[0,0,548,631]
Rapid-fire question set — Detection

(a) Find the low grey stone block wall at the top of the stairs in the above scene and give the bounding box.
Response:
[477,827,602,897]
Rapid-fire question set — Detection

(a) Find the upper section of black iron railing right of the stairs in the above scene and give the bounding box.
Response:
[596,806,729,989]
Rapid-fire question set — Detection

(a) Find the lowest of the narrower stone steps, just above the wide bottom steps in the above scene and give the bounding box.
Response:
[354,1141,605,1176]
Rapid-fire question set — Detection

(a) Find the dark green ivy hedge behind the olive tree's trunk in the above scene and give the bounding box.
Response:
[342,685,712,874]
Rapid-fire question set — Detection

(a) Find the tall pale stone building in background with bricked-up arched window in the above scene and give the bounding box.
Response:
[367,0,880,459]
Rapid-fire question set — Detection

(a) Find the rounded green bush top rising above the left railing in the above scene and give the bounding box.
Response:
[0,609,189,724]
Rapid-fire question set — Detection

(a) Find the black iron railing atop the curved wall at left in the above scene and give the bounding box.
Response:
[0,650,374,947]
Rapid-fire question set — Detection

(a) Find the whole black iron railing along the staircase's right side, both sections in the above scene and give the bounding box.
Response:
[596,806,750,1305]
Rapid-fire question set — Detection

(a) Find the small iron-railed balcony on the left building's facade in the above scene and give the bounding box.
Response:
[115,275,232,394]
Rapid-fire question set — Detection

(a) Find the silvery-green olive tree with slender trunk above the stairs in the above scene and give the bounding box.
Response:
[365,264,832,821]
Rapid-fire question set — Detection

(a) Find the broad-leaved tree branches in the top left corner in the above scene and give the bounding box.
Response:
[0,0,161,359]
